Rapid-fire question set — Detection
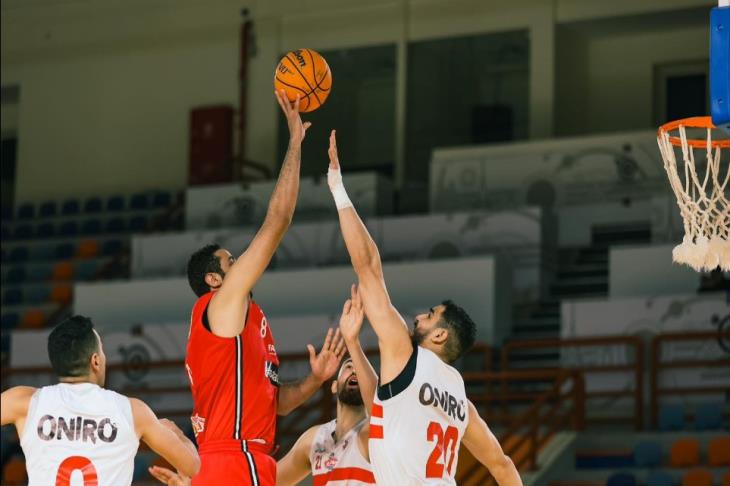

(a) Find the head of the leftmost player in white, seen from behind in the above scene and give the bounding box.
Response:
[48,316,106,386]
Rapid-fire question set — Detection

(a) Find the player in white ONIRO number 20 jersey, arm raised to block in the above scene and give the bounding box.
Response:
[327,130,522,486]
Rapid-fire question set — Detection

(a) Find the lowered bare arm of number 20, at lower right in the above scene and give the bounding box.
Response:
[462,401,522,486]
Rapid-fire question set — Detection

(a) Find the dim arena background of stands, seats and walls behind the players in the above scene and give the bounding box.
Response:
[0,0,730,486]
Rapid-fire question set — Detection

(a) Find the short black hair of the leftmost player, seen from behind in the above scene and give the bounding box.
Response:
[48,316,99,377]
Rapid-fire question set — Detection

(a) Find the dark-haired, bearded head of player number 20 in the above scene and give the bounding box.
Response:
[411,300,476,363]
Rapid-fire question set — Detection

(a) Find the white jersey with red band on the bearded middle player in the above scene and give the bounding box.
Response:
[309,418,375,486]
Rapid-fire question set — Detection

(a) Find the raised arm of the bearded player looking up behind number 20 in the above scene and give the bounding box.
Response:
[340,285,378,415]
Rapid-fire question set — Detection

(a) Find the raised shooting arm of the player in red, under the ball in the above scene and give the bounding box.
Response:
[208,89,310,337]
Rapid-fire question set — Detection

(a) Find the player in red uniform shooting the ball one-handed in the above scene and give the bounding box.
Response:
[185,92,344,486]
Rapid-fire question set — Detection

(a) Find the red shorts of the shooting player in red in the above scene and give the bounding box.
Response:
[193,441,276,486]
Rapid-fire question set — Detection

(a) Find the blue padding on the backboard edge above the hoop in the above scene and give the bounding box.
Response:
[710,7,730,133]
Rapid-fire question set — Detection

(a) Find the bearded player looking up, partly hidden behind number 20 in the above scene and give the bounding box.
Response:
[150,287,378,486]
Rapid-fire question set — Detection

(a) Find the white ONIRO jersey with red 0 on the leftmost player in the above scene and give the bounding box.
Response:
[20,383,139,486]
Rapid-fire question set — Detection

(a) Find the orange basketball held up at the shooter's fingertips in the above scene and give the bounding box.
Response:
[274,49,332,113]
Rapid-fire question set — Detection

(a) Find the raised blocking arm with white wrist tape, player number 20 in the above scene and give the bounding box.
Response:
[327,130,413,383]
